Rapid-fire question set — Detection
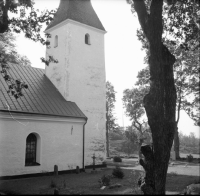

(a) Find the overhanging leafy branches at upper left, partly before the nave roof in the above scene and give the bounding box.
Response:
[0,0,57,99]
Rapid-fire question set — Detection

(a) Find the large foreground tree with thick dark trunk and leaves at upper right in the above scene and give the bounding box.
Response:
[126,0,199,194]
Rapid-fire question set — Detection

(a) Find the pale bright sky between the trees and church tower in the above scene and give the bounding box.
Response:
[14,0,200,137]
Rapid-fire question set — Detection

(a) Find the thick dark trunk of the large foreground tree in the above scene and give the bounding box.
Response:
[134,0,176,194]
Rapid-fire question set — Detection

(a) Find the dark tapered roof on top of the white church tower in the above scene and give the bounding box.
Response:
[46,0,105,31]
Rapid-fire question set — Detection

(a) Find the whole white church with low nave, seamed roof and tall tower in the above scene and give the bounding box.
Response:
[0,0,106,177]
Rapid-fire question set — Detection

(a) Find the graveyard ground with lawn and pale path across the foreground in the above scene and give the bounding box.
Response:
[0,158,200,195]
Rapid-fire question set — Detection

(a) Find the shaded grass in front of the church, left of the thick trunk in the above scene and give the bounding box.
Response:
[0,168,143,195]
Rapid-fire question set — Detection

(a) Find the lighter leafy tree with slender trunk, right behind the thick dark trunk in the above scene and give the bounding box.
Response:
[134,24,200,159]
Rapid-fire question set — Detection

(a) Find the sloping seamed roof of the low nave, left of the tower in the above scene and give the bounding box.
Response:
[0,65,86,118]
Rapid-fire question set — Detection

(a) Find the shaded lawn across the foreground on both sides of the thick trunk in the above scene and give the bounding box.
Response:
[0,168,199,195]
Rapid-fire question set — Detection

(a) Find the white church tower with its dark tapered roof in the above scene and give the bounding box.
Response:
[45,0,106,165]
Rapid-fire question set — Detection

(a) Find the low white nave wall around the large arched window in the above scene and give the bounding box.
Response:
[0,114,85,176]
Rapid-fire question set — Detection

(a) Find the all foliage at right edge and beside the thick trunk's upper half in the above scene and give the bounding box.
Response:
[134,1,200,126]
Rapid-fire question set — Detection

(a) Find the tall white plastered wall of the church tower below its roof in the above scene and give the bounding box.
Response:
[46,20,106,164]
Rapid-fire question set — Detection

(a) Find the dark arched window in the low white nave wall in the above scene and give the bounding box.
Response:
[25,133,39,166]
